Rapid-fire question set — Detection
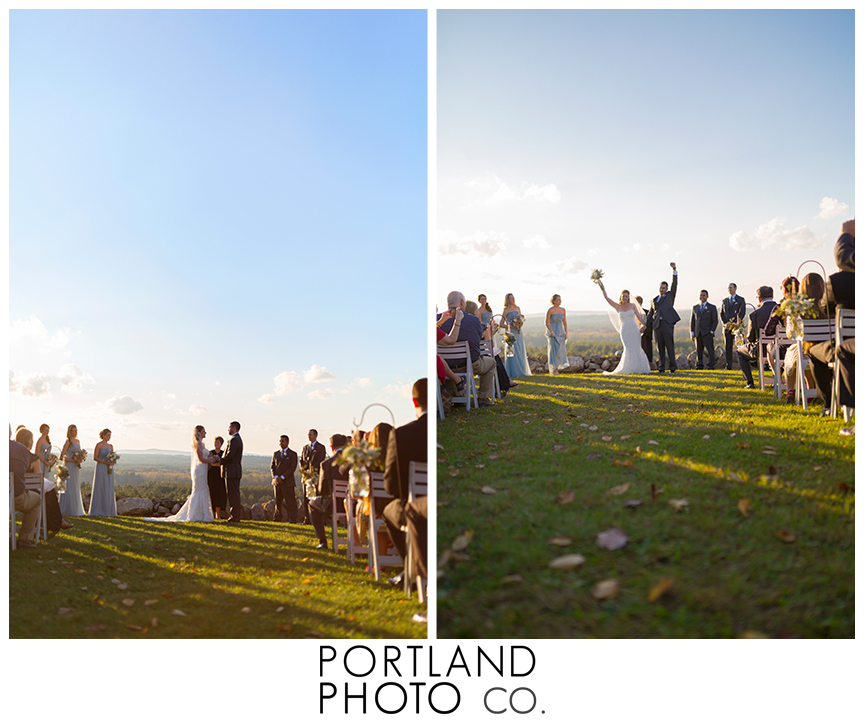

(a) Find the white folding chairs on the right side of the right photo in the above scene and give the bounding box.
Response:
[758,308,855,422]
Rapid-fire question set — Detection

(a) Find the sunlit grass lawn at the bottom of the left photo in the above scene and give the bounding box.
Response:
[9,517,426,638]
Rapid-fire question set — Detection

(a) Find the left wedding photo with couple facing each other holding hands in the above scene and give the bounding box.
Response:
[8,11,427,639]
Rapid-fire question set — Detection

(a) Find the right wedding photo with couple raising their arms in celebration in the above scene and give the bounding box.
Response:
[430,10,855,639]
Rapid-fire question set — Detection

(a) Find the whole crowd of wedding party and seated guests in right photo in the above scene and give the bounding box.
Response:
[436,219,855,435]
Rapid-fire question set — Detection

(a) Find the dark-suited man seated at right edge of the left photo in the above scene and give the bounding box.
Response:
[384,376,426,585]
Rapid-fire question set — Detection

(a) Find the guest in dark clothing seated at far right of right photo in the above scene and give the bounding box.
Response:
[807,220,855,415]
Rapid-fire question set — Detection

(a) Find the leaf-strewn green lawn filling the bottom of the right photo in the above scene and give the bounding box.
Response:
[438,370,855,638]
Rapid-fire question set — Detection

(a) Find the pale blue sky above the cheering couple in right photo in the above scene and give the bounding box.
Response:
[434,10,855,313]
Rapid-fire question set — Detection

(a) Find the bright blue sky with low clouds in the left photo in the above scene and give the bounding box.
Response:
[9,11,428,453]
